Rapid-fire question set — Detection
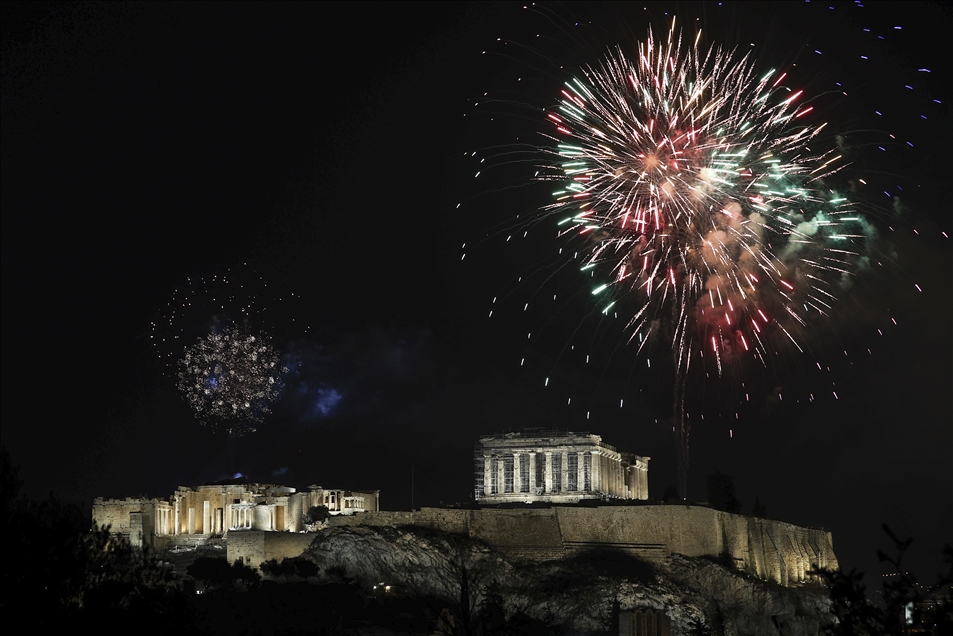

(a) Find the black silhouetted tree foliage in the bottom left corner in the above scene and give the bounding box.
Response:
[0,451,190,634]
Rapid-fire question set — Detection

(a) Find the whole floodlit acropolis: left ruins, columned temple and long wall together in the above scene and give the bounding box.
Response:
[93,431,837,586]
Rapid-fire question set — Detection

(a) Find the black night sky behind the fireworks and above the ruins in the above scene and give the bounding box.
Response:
[0,3,953,592]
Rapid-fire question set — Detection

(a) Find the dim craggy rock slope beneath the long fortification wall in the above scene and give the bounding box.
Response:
[302,526,831,636]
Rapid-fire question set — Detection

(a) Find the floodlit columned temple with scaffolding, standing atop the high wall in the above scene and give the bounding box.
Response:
[474,431,650,504]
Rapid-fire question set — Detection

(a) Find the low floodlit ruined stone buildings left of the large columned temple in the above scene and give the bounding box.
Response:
[93,483,380,550]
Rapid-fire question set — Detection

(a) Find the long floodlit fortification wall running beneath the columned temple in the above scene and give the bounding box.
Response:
[329,505,837,585]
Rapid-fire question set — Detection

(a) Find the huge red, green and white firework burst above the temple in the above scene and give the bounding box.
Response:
[544,30,865,377]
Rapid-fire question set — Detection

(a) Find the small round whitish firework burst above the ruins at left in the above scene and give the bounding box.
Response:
[178,325,288,435]
